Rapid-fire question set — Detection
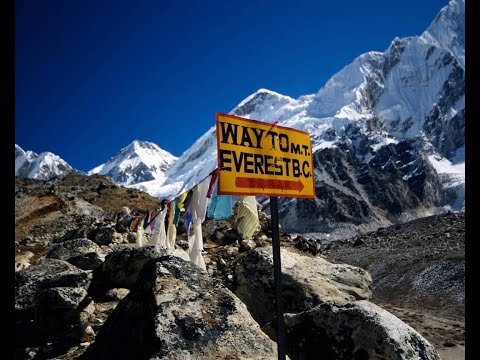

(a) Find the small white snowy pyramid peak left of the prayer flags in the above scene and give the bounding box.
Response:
[88,140,177,186]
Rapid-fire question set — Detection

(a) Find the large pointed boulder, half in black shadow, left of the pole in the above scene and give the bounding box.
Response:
[80,256,277,360]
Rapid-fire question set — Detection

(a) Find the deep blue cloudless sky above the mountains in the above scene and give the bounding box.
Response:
[15,0,447,171]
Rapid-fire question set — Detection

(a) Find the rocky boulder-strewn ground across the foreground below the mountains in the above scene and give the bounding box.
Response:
[15,175,465,359]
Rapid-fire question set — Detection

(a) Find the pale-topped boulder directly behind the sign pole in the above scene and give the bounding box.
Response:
[235,247,372,326]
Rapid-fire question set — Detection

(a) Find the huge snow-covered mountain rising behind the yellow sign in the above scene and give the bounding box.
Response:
[136,0,465,235]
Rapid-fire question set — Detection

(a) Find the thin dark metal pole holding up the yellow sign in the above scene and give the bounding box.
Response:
[270,196,285,360]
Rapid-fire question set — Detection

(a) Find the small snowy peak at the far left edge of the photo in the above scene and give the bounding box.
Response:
[15,144,74,180]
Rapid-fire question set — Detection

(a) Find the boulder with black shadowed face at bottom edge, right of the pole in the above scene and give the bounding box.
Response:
[285,300,440,360]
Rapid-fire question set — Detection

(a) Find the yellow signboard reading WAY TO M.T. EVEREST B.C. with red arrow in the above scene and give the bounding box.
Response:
[216,113,315,198]
